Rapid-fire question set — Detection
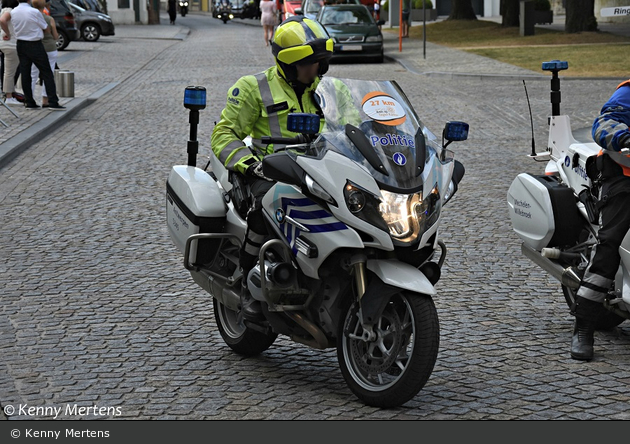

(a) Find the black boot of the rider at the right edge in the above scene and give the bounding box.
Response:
[571,296,605,361]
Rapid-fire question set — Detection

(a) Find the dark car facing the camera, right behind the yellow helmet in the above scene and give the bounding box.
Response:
[317,5,385,62]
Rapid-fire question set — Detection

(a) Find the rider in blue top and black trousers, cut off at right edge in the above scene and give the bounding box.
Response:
[571,80,630,361]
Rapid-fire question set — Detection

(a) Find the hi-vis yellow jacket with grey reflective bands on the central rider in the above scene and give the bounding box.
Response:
[211,66,320,173]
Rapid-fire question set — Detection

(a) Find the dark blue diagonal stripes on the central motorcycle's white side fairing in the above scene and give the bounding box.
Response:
[276,197,348,255]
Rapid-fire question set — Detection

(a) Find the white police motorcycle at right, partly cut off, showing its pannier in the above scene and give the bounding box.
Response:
[507,60,630,330]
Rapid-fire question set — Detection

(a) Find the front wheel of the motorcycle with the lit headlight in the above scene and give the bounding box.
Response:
[337,292,440,408]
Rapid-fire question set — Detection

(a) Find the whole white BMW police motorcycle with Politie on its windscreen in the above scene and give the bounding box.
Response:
[166,77,468,407]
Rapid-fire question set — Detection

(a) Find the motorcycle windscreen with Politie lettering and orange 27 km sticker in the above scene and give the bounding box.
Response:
[315,77,441,192]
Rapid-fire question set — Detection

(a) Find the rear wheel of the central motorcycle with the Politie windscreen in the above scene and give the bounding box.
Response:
[212,298,278,356]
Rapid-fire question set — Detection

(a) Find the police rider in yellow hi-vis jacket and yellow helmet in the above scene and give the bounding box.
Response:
[211,16,333,321]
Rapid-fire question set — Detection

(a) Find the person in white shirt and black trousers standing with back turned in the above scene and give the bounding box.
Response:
[0,0,66,110]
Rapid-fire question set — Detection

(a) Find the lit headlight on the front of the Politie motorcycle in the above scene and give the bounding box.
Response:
[379,187,440,242]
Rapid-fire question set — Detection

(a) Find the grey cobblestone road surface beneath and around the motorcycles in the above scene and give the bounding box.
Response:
[0,13,630,420]
